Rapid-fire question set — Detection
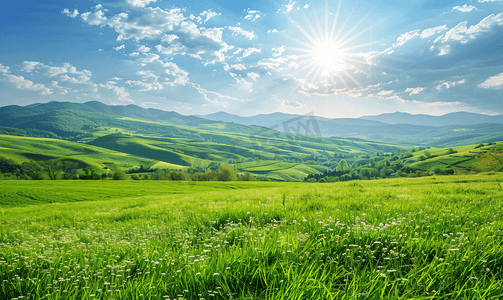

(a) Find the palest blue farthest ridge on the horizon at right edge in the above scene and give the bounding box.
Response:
[360,112,503,127]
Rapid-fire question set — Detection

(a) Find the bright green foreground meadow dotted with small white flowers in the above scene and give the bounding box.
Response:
[0,174,503,299]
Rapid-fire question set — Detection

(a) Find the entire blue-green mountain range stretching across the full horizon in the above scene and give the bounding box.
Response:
[0,101,503,147]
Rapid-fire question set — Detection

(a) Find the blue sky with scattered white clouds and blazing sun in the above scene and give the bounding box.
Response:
[0,0,503,118]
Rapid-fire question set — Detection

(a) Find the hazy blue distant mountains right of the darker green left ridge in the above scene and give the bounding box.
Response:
[199,112,503,147]
